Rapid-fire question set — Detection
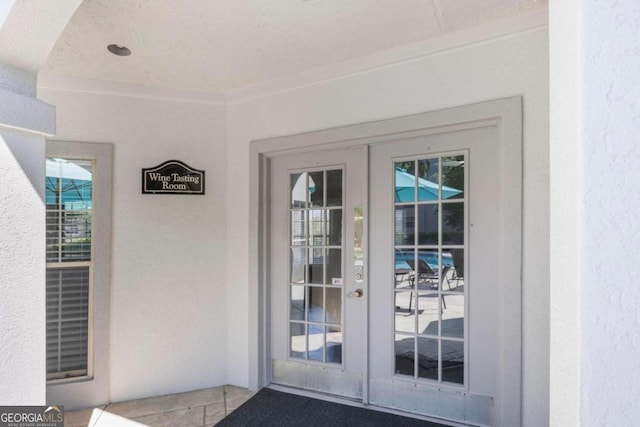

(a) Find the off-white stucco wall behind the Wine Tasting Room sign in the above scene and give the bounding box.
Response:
[39,87,227,401]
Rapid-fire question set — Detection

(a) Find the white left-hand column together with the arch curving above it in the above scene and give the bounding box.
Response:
[0,0,82,405]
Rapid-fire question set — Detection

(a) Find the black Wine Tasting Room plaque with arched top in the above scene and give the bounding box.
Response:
[142,160,204,194]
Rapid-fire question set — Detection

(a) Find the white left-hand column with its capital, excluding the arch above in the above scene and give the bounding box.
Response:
[0,64,55,405]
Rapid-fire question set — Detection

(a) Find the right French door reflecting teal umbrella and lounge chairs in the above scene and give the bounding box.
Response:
[368,126,503,425]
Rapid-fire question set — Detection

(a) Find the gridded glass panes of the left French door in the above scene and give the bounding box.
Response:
[288,168,345,364]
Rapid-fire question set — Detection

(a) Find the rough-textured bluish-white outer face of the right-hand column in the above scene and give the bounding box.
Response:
[581,1,640,427]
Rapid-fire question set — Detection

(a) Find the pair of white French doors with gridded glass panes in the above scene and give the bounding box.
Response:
[267,102,521,426]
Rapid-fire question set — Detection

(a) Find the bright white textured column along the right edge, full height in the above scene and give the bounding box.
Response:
[550,0,640,427]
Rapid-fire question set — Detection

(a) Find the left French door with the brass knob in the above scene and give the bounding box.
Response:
[270,148,366,399]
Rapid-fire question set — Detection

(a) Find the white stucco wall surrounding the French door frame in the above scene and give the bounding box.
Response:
[227,17,549,426]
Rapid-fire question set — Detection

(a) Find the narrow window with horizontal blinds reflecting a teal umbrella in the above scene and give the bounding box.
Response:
[46,158,94,380]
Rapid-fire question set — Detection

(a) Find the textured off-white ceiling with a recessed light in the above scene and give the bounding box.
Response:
[44,0,547,93]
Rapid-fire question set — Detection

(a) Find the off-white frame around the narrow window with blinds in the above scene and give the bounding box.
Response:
[46,140,113,407]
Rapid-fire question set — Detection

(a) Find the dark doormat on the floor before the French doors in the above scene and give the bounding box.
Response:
[216,388,446,427]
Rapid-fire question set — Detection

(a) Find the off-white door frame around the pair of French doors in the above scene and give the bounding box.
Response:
[248,96,522,425]
